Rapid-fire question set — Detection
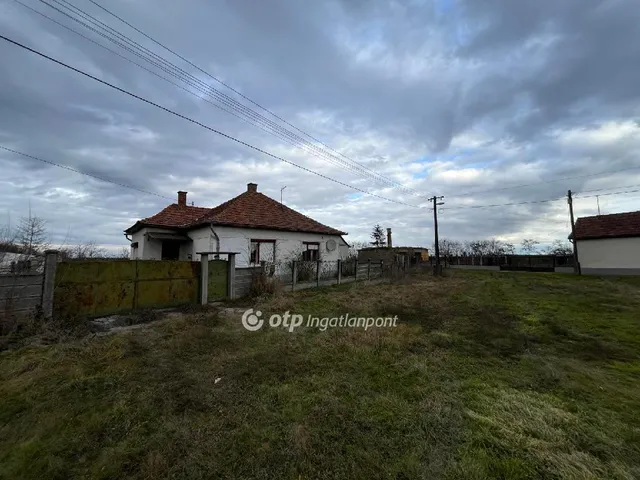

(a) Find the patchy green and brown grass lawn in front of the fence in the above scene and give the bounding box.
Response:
[0,271,640,480]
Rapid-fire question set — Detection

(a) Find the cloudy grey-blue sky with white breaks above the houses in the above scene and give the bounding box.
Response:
[0,0,640,253]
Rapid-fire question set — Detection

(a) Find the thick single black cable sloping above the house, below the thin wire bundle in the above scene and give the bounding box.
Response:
[0,31,420,208]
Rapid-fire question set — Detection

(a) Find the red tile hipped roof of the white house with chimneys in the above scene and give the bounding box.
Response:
[125,191,346,235]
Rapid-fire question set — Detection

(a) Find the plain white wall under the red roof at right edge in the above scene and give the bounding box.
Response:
[578,237,640,273]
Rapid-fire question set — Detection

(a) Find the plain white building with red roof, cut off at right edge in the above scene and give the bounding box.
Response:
[569,211,640,275]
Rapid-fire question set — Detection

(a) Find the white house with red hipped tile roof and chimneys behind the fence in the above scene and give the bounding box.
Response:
[125,183,349,267]
